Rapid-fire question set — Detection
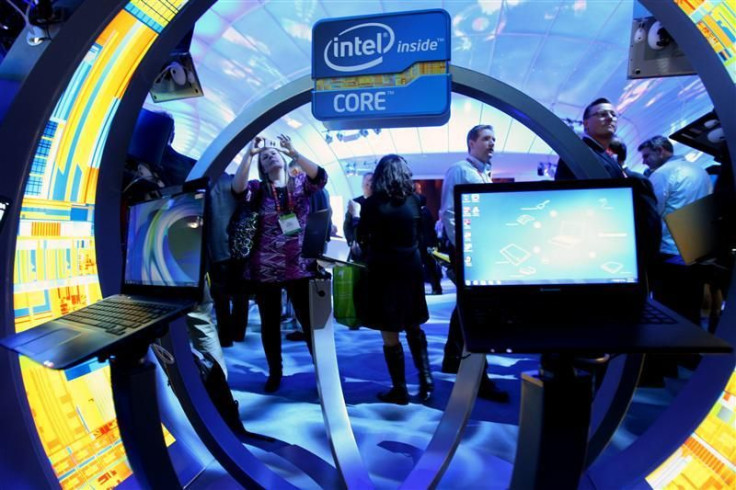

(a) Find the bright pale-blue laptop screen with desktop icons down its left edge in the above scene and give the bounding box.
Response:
[456,188,638,286]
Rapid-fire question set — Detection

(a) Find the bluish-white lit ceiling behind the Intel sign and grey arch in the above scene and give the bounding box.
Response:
[146,0,712,180]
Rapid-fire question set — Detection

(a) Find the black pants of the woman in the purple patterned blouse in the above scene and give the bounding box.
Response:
[256,278,312,373]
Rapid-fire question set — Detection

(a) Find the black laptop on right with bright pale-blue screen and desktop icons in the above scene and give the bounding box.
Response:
[454,179,732,353]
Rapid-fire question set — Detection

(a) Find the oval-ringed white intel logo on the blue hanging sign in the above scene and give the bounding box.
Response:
[324,22,395,72]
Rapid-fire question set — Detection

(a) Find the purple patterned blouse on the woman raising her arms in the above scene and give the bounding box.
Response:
[240,167,327,283]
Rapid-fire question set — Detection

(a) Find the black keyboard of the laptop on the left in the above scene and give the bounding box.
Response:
[64,298,176,335]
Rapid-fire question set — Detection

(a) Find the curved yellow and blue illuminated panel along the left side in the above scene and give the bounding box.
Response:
[13,0,186,489]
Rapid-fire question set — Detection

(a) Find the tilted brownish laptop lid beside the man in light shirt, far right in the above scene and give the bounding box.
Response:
[664,194,723,265]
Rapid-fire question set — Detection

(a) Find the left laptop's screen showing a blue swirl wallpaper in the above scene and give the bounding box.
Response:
[124,190,205,288]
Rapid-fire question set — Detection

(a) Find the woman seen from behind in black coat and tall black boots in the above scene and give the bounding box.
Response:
[357,155,434,405]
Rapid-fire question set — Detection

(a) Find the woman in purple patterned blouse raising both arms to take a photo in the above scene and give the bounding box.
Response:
[232,135,327,393]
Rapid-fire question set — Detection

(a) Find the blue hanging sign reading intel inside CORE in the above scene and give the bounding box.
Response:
[312,10,451,129]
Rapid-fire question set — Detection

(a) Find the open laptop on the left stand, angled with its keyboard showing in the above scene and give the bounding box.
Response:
[0,188,206,369]
